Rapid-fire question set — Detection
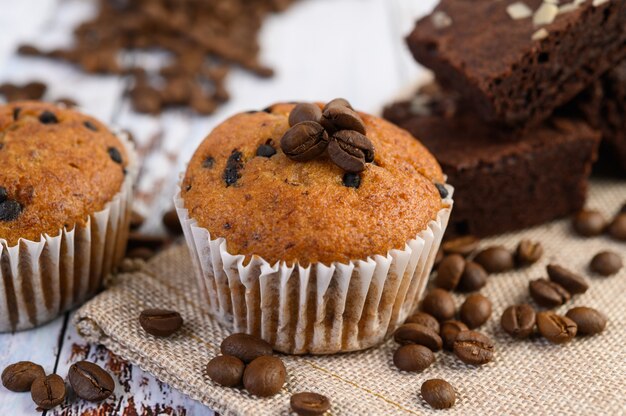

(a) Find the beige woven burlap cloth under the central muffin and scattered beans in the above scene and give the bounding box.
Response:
[76,180,626,416]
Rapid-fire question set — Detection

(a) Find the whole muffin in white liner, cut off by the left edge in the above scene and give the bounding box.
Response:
[0,102,134,331]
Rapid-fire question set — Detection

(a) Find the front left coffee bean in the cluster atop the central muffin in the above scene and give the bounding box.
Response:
[280,121,328,162]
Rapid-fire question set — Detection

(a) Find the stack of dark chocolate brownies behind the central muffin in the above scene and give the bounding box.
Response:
[384,0,626,236]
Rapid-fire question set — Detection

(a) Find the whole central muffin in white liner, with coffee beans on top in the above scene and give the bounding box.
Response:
[176,99,452,353]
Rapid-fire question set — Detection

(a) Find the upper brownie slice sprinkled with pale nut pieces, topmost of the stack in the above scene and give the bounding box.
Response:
[407,0,626,127]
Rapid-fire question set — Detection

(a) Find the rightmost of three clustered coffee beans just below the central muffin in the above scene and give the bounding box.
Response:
[243,356,287,397]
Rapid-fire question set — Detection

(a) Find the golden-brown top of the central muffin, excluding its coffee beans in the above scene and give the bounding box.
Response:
[181,104,443,265]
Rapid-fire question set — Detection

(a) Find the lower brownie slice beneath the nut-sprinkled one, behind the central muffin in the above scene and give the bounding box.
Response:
[384,85,600,236]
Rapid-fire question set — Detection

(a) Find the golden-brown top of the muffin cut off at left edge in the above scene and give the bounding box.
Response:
[0,101,128,246]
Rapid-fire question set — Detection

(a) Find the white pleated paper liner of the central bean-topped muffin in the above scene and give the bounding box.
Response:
[174,185,453,354]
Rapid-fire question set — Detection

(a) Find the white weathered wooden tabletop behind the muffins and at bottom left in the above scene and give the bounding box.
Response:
[0,0,436,416]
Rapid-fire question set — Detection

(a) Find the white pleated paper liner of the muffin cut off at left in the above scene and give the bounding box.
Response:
[0,133,137,332]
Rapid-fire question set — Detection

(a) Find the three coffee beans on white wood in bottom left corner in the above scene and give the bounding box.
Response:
[2,361,115,410]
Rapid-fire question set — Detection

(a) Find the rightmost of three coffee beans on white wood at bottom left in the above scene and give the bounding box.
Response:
[67,361,115,402]
